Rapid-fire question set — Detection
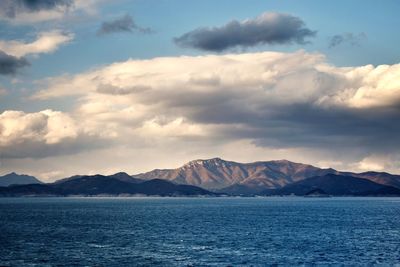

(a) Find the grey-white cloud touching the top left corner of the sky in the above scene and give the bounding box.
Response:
[0,0,103,24]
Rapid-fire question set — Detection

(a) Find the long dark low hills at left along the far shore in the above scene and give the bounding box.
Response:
[0,175,216,196]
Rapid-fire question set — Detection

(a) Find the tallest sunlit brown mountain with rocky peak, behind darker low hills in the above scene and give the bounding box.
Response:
[133,158,337,193]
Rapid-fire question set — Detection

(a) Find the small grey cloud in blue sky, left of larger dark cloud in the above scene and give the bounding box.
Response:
[97,14,151,35]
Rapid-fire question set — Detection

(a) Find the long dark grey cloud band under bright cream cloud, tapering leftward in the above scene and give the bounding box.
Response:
[184,97,400,157]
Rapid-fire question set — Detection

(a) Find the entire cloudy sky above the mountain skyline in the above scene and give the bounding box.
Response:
[0,0,400,181]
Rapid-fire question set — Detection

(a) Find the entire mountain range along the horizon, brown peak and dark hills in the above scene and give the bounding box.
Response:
[0,158,400,196]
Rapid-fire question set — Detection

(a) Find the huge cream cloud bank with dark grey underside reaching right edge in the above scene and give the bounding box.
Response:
[30,51,400,157]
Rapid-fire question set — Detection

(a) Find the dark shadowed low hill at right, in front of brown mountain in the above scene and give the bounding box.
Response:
[263,174,400,196]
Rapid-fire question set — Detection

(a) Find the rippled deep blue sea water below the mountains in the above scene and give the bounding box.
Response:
[0,197,400,266]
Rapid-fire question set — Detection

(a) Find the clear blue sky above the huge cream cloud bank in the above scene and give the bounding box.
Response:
[1,0,400,79]
